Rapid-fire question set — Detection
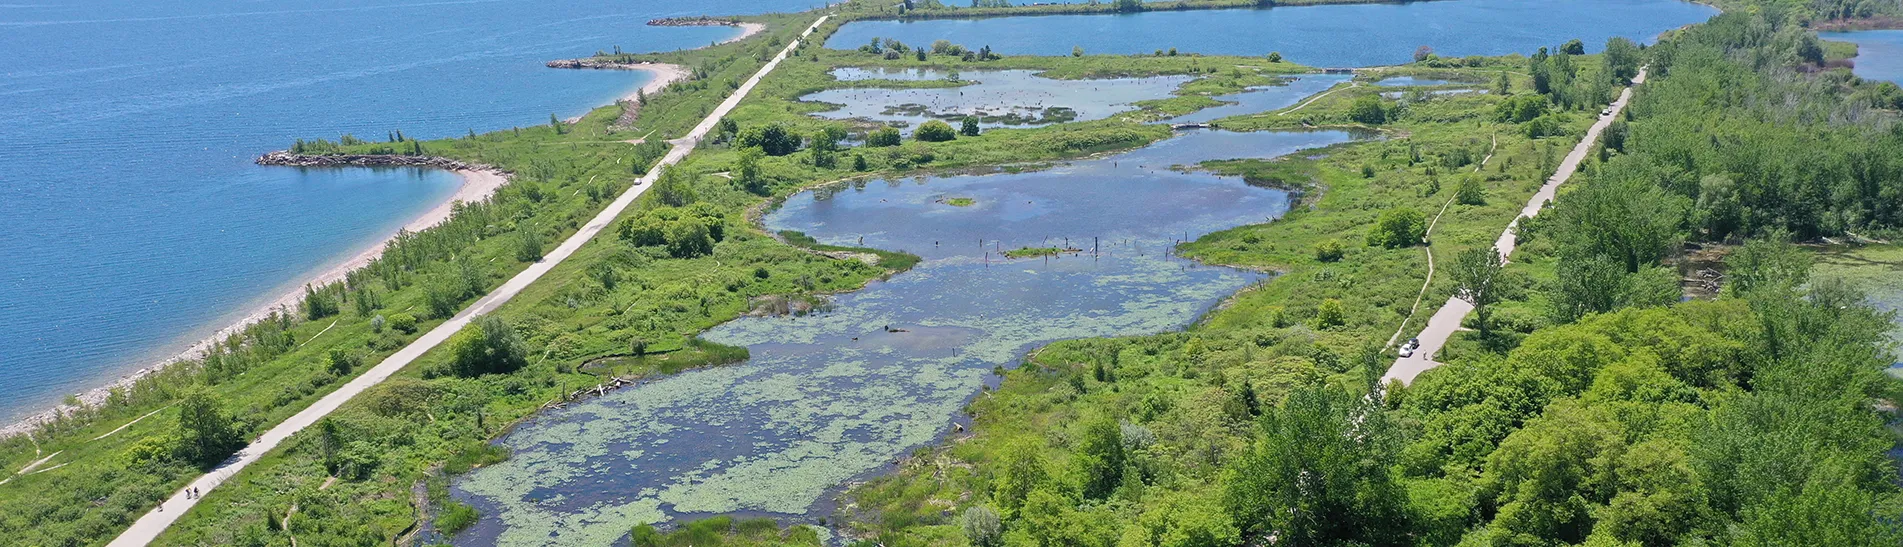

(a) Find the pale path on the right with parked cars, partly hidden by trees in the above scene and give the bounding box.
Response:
[1382,69,1646,385]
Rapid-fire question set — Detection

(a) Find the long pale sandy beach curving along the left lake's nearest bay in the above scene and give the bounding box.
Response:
[0,170,508,438]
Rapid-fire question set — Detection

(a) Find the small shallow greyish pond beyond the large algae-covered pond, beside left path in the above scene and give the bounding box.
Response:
[799,69,1191,128]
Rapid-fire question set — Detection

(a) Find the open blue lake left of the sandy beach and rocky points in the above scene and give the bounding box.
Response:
[0,0,811,421]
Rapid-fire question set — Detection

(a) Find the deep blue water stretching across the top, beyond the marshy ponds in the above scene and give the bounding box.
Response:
[826,0,1718,67]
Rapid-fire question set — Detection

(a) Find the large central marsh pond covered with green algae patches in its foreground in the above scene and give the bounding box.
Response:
[455,132,1351,545]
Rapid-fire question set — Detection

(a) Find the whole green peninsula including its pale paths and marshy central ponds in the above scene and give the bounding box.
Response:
[11,0,1903,545]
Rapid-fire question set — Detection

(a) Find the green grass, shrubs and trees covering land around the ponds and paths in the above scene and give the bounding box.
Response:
[11,2,1903,547]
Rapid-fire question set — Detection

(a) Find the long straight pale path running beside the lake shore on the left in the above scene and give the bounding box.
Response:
[108,15,832,547]
